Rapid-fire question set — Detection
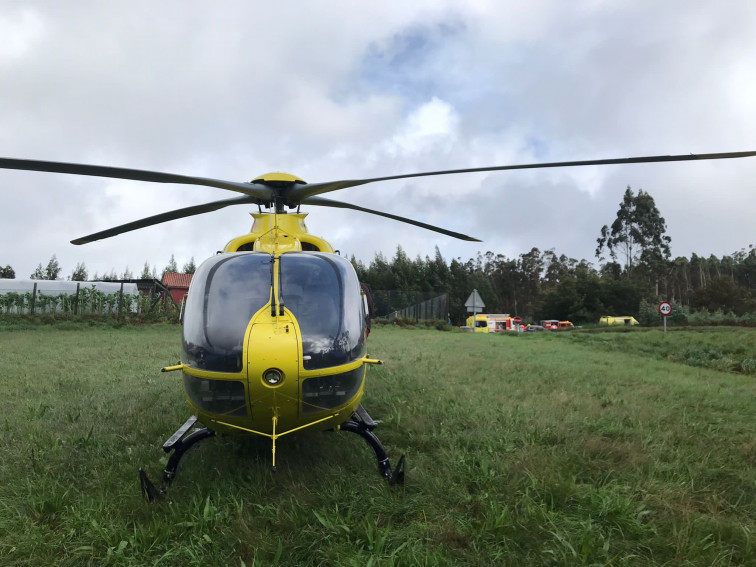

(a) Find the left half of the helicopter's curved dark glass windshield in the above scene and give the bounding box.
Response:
[183,252,271,372]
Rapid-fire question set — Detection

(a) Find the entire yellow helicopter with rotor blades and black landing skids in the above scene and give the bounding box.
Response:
[0,151,756,500]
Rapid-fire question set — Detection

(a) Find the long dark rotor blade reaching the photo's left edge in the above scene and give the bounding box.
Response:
[0,158,275,203]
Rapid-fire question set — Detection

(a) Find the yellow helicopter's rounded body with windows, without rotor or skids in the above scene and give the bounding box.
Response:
[173,213,377,440]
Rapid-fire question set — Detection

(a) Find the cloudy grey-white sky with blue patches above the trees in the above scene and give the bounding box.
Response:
[0,0,756,278]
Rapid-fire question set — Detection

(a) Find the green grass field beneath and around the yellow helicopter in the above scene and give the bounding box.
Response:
[0,323,756,567]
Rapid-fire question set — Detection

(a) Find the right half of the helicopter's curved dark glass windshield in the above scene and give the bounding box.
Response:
[279,252,365,370]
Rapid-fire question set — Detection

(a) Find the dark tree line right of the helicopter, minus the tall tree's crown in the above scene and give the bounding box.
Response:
[351,246,756,325]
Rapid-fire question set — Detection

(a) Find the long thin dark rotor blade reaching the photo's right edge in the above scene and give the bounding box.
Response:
[284,151,756,204]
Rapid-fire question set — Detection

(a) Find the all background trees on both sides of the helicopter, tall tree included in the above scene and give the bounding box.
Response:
[5,187,756,324]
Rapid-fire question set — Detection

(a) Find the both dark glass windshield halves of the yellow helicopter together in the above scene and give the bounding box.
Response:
[183,252,366,373]
